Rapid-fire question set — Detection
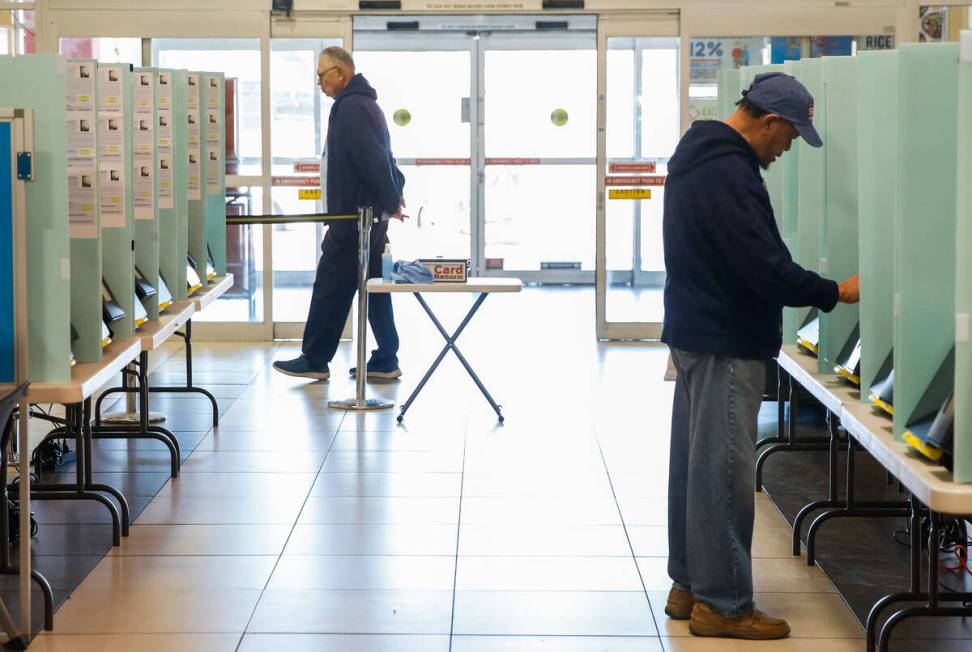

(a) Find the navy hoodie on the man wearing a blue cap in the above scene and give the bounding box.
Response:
[662,120,838,359]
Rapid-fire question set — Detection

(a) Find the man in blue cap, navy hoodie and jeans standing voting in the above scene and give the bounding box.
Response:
[662,73,858,639]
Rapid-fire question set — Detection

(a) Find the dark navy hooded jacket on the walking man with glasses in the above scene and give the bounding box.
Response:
[325,74,405,252]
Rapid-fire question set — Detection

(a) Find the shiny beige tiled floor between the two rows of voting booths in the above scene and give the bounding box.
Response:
[9,289,966,652]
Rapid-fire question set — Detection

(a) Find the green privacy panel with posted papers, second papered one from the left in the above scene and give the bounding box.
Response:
[98,63,135,340]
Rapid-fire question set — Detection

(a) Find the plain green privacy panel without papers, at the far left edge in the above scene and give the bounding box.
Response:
[0,54,71,383]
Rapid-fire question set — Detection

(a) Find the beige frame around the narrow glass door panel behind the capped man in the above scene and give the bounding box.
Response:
[594,11,688,340]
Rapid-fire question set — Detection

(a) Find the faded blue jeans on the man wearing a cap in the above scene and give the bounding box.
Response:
[668,349,766,616]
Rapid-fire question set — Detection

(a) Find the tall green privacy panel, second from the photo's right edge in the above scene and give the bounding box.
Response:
[894,43,959,437]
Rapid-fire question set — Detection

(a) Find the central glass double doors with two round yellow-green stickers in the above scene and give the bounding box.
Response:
[354,16,596,283]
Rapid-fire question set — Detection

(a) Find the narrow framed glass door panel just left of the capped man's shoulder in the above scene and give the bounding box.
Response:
[596,17,681,339]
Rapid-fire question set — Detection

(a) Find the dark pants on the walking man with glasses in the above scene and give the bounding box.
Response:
[302,224,398,369]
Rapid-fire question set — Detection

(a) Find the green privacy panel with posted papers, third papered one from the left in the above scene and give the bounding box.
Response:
[132,68,161,319]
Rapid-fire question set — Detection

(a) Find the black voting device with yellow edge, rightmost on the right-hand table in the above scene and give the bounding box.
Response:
[902,347,955,466]
